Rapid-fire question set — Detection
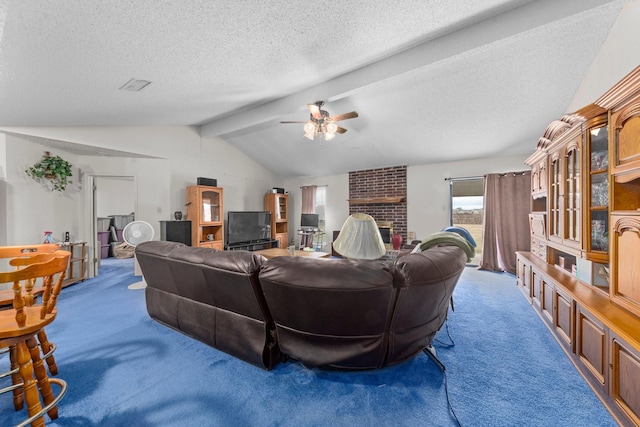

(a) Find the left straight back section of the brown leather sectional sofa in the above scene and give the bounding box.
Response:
[136,241,280,369]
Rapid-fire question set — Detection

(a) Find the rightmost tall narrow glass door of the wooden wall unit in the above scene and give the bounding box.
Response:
[585,125,609,262]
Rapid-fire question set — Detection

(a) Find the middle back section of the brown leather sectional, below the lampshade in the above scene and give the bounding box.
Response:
[260,257,395,368]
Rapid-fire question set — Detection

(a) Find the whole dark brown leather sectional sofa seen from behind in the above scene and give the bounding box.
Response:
[136,241,467,369]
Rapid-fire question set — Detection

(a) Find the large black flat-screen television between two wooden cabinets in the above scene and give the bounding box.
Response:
[227,211,271,246]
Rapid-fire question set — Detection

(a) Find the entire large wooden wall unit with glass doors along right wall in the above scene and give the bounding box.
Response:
[516,67,640,426]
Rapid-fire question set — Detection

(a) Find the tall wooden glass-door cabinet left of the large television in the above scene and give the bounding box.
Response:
[186,185,224,251]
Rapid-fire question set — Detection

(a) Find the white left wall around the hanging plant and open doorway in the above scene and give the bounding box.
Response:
[0,126,282,278]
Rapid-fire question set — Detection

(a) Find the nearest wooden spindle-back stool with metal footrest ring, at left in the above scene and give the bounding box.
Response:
[0,250,71,426]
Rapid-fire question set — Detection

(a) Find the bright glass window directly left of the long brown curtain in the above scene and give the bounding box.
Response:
[449,177,484,265]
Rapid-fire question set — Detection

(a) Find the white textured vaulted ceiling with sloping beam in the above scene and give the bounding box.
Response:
[0,0,630,177]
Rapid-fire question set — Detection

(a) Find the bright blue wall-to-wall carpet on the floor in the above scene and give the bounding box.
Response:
[0,259,616,427]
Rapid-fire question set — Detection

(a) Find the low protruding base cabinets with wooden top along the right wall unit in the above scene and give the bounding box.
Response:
[516,252,640,426]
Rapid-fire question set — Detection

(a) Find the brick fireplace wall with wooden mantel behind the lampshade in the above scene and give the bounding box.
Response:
[349,166,407,242]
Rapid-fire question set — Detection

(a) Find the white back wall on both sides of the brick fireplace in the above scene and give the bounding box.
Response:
[285,154,535,247]
